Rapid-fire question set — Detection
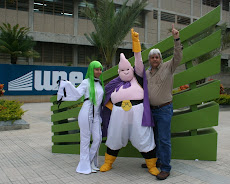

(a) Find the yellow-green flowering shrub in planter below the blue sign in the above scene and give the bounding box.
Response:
[0,100,26,123]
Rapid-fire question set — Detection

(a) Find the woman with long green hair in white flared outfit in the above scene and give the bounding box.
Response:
[57,61,104,174]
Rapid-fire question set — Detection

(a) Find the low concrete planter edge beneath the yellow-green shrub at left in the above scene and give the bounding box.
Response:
[0,119,30,131]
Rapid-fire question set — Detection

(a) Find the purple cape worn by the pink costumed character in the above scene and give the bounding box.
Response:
[101,69,154,137]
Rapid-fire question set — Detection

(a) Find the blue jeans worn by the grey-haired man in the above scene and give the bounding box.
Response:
[152,104,173,172]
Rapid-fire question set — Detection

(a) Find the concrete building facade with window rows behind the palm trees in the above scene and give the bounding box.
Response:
[0,0,230,66]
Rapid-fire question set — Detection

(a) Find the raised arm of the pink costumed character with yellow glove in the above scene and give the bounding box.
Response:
[131,29,144,77]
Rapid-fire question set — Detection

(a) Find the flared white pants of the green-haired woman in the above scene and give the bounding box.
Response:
[76,107,102,174]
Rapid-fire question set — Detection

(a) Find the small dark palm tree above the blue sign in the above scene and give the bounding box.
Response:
[0,23,39,64]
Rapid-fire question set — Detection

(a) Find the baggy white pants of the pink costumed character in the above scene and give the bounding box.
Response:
[106,103,156,152]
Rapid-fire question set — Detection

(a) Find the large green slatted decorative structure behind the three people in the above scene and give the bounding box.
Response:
[50,6,221,160]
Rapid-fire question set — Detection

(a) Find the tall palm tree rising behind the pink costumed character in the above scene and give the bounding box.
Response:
[82,0,147,68]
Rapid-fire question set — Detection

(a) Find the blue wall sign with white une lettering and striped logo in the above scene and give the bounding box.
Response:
[0,64,87,95]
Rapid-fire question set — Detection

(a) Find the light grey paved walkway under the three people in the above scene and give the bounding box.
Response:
[0,103,230,184]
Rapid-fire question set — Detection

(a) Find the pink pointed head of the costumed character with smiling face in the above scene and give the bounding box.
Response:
[118,53,134,81]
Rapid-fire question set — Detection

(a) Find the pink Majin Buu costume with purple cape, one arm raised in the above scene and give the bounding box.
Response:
[100,30,159,175]
